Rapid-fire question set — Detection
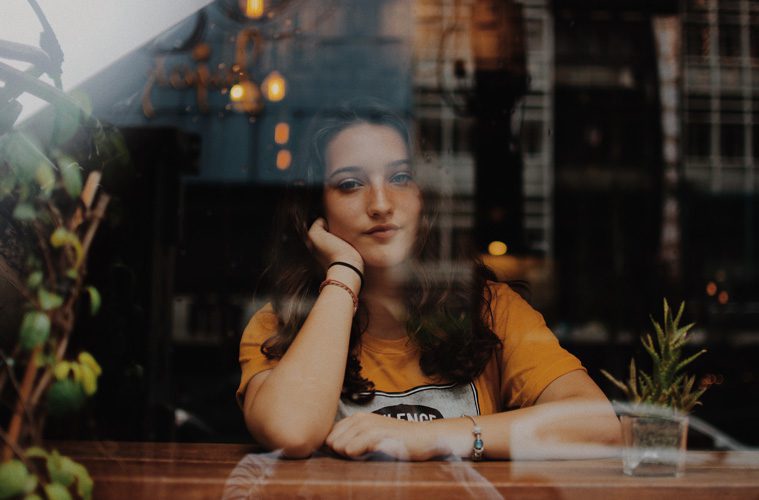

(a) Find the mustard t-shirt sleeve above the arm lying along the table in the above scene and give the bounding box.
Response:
[491,284,587,408]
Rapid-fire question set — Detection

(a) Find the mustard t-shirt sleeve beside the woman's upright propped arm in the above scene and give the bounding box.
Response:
[236,304,278,407]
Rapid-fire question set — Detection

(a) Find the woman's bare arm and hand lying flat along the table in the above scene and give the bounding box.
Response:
[326,370,621,460]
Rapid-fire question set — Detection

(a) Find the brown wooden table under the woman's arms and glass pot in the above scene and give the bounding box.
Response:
[51,442,759,500]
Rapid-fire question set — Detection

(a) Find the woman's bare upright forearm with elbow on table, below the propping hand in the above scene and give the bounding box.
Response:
[245,268,360,456]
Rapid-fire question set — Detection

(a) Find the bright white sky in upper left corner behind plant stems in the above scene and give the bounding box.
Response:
[0,0,212,124]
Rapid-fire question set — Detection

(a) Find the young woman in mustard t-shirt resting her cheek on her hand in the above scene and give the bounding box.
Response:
[237,99,619,460]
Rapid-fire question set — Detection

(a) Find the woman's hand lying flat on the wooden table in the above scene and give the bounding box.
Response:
[325,413,447,460]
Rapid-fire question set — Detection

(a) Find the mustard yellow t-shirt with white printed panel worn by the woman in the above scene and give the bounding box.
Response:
[237,282,585,421]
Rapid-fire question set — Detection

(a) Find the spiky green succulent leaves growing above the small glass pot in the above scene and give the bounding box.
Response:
[601,299,707,413]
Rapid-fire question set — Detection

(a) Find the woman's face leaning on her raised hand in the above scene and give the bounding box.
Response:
[324,123,422,267]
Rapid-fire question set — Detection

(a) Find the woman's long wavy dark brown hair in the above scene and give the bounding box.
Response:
[261,100,500,402]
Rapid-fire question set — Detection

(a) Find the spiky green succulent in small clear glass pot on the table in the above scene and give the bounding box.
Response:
[601,299,707,476]
